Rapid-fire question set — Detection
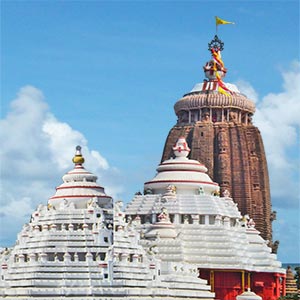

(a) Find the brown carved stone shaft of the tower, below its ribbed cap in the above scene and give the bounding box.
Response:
[162,117,272,241]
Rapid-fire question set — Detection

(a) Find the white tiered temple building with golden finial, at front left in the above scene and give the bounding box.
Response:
[0,147,214,300]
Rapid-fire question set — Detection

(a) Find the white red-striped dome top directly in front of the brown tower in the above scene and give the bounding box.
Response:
[144,137,220,194]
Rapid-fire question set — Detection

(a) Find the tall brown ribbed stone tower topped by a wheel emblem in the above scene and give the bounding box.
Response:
[162,36,278,247]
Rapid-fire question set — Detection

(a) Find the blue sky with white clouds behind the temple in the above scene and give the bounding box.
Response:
[0,0,300,262]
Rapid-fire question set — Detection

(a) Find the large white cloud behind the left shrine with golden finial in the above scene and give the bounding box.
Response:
[0,86,122,244]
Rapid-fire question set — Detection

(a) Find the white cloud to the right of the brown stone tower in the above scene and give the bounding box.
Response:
[239,61,300,207]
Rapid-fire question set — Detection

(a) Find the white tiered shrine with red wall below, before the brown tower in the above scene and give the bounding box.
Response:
[125,137,285,300]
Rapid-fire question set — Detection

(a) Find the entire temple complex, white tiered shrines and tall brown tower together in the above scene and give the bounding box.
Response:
[0,36,286,300]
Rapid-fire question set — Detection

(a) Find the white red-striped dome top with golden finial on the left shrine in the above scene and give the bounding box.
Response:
[48,146,111,208]
